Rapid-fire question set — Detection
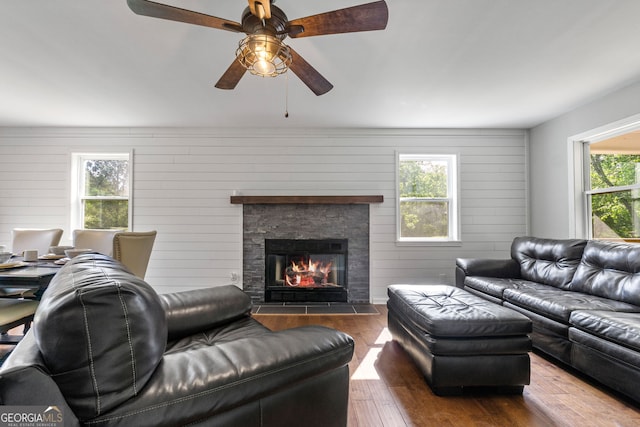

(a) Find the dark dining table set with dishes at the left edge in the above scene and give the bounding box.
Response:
[0,256,62,300]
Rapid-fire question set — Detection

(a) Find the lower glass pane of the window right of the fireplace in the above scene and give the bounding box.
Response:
[400,200,449,238]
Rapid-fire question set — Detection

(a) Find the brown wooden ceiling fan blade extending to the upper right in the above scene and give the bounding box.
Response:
[288,0,389,38]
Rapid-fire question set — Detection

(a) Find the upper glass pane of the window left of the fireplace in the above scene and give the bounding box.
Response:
[84,160,129,197]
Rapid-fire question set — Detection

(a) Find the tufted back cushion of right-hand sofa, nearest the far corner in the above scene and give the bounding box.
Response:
[511,236,587,289]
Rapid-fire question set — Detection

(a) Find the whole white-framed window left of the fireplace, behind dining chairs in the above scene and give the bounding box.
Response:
[71,153,131,230]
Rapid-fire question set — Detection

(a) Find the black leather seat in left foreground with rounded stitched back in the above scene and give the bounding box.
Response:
[0,254,354,427]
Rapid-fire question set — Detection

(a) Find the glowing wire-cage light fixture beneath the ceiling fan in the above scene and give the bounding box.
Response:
[236,34,291,77]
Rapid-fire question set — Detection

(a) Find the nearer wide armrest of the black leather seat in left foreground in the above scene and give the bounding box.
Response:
[92,326,354,426]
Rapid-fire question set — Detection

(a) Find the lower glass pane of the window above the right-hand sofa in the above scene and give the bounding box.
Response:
[591,190,640,239]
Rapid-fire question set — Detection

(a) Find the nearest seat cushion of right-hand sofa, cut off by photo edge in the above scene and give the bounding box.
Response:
[569,307,640,351]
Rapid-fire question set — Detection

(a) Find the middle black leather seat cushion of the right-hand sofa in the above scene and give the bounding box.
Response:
[504,287,638,324]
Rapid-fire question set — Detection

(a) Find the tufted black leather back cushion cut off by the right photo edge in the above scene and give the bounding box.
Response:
[571,240,640,306]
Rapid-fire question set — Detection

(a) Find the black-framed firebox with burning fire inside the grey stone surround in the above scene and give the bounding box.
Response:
[264,239,348,302]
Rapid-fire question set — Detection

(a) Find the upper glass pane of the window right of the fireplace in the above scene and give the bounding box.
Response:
[399,158,448,198]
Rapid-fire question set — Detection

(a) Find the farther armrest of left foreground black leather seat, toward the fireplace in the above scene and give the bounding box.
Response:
[159,285,251,339]
